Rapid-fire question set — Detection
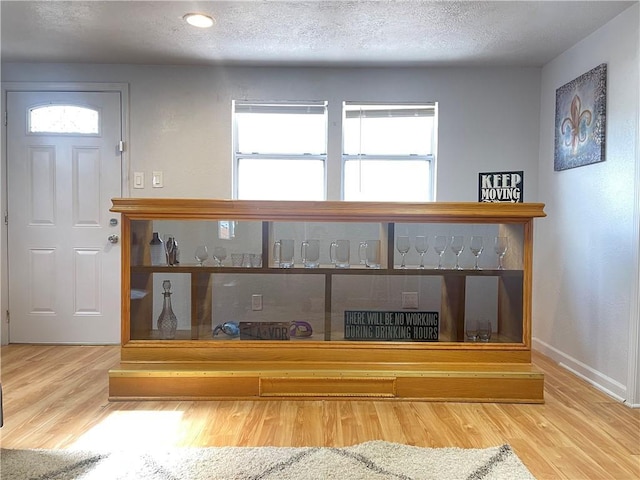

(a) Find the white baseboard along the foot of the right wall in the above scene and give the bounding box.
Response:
[532,338,640,408]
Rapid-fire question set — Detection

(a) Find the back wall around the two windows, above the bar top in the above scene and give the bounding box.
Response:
[2,63,540,201]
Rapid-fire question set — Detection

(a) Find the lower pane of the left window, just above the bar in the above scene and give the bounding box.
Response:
[238,158,324,200]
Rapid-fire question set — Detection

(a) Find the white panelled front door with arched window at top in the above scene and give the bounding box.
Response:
[7,91,122,343]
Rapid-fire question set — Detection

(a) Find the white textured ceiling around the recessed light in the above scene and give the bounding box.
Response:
[0,0,637,66]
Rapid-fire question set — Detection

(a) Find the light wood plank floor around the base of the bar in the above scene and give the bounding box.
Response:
[0,345,640,480]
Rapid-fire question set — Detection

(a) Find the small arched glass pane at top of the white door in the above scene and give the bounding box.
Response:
[29,105,100,135]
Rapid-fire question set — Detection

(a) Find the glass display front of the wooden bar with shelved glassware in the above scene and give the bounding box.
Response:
[130,220,524,343]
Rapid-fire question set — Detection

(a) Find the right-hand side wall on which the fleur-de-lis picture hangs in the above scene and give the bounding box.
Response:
[533,4,640,404]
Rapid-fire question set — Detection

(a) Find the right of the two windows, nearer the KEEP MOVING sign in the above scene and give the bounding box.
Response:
[342,102,436,202]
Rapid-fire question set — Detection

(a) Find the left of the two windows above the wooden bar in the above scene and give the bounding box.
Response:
[233,101,327,200]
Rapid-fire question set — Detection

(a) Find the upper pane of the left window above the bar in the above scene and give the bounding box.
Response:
[236,113,327,154]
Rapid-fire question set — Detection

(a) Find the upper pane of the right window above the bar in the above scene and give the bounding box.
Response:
[344,116,434,155]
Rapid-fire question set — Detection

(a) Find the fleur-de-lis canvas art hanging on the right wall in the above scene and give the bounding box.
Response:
[554,63,607,171]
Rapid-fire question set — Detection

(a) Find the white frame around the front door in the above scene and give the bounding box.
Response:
[0,82,131,345]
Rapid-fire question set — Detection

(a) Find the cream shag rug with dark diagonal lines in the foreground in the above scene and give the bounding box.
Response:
[0,441,535,480]
